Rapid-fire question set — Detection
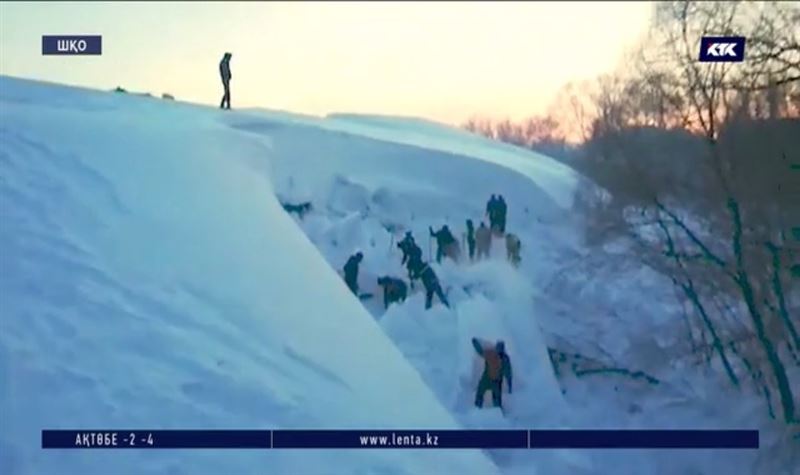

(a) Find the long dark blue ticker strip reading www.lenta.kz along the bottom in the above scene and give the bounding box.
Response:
[42,429,759,449]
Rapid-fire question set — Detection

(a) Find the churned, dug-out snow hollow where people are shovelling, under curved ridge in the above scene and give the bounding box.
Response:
[230,103,797,474]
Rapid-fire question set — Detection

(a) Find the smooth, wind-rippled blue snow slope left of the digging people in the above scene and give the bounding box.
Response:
[0,77,495,474]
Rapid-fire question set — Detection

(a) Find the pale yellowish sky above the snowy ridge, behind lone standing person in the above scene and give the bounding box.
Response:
[0,2,653,124]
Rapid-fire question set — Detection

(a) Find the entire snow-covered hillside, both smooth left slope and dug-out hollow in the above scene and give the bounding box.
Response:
[0,77,793,475]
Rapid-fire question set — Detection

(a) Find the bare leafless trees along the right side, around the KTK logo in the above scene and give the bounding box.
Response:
[584,2,800,423]
